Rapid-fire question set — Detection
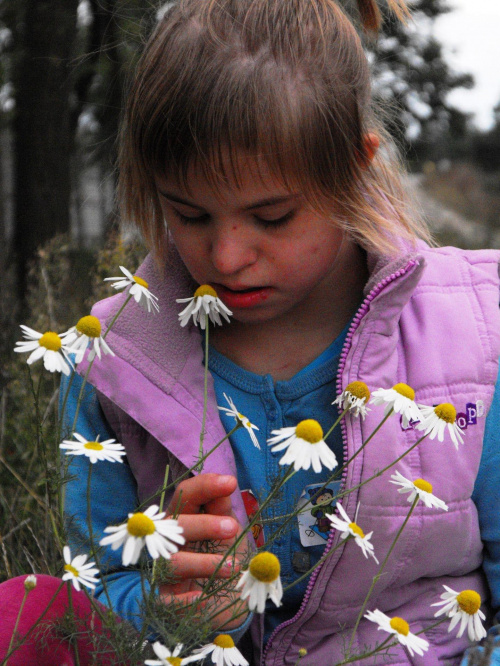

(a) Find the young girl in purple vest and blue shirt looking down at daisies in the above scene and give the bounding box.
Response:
[3,0,500,666]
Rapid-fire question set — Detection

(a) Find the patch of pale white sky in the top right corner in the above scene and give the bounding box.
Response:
[433,0,500,129]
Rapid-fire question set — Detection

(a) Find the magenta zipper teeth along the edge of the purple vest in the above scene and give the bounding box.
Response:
[262,259,419,664]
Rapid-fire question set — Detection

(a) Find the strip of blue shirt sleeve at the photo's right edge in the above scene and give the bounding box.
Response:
[461,364,500,666]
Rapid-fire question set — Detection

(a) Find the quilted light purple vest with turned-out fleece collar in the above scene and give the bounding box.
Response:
[80,244,500,666]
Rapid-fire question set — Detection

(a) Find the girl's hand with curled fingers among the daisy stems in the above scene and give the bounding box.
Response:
[160,474,248,631]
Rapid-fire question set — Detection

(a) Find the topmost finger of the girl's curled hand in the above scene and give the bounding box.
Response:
[169,474,237,514]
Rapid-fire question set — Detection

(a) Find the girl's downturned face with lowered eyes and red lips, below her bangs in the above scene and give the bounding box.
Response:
[157,151,352,323]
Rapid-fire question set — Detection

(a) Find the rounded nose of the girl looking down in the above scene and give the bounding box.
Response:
[211,224,258,275]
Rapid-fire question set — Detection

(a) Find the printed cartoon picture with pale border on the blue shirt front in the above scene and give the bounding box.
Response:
[297,481,340,546]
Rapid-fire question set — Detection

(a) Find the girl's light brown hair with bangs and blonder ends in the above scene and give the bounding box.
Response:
[119,0,429,260]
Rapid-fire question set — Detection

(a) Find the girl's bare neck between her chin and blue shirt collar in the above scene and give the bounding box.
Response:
[211,243,368,381]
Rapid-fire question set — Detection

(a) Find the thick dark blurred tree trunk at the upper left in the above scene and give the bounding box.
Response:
[13,0,78,298]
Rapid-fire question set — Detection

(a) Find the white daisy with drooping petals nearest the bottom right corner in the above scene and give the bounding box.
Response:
[431,585,486,641]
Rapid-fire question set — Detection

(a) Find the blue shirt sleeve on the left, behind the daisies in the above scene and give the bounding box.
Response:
[60,373,150,630]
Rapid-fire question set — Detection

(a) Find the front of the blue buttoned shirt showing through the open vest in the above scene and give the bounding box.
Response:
[208,325,349,640]
